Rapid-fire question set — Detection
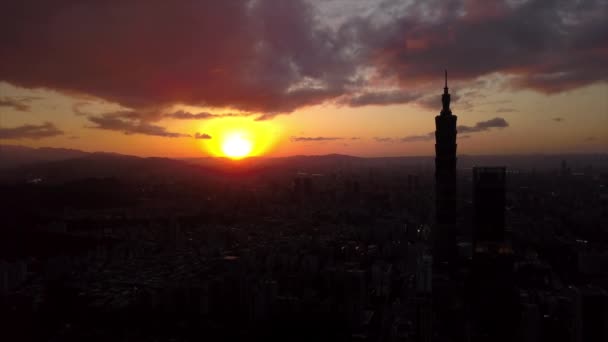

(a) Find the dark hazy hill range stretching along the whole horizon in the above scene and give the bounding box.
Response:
[0,145,608,183]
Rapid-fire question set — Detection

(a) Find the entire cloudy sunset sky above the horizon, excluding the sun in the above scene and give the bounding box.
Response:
[0,0,608,157]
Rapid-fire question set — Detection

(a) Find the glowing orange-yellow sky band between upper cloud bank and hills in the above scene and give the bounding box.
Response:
[0,83,608,157]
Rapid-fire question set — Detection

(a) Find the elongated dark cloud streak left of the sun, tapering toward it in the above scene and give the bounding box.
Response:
[87,112,190,138]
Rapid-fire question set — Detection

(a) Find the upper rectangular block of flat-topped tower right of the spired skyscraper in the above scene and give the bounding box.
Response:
[473,167,506,250]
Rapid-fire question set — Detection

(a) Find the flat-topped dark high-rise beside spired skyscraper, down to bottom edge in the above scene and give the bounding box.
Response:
[468,167,516,342]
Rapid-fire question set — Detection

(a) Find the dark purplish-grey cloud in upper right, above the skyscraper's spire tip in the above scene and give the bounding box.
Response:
[370,0,608,93]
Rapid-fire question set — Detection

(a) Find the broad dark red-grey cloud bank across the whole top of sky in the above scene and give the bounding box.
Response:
[0,0,608,117]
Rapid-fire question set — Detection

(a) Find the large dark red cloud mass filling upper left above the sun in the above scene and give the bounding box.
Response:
[0,0,356,116]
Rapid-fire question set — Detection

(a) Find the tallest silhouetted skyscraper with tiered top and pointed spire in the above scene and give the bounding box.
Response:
[433,70,457,264]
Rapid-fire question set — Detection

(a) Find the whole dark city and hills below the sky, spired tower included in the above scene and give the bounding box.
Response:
[0,71,608,342]
